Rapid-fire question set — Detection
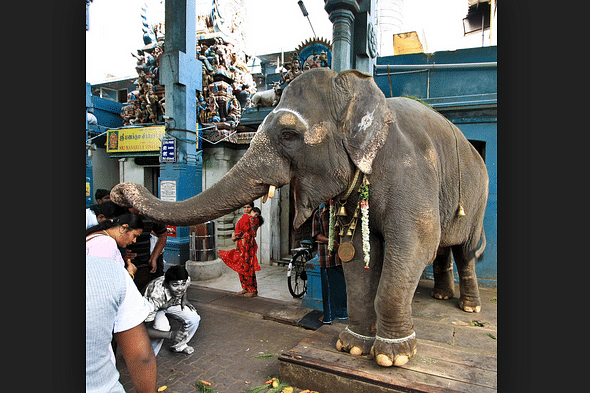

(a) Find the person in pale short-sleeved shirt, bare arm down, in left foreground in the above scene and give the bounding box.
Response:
[86,256,157,393]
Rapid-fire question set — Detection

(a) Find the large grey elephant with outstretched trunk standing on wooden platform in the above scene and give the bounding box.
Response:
[111,68,489,367]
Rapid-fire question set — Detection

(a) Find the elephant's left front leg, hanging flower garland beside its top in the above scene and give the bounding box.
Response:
[336,236,383,356]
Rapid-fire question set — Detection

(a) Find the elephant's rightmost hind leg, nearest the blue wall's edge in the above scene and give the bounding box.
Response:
[453,244,481,312]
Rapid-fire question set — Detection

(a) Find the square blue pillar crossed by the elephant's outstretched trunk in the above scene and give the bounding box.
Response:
[159,0,203,269]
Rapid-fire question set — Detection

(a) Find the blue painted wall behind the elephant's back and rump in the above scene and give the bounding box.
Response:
[373,46,498,286]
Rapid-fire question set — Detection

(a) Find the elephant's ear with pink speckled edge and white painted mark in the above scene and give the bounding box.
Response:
[334,70,394,174]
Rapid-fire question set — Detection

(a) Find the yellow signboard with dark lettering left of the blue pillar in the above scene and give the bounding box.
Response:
[107,126,164,153]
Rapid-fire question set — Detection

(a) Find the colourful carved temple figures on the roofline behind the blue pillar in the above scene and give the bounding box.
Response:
[121,2,332,143]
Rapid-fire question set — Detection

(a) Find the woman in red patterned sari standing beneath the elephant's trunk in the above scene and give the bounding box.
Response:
[219,203,264,297]
